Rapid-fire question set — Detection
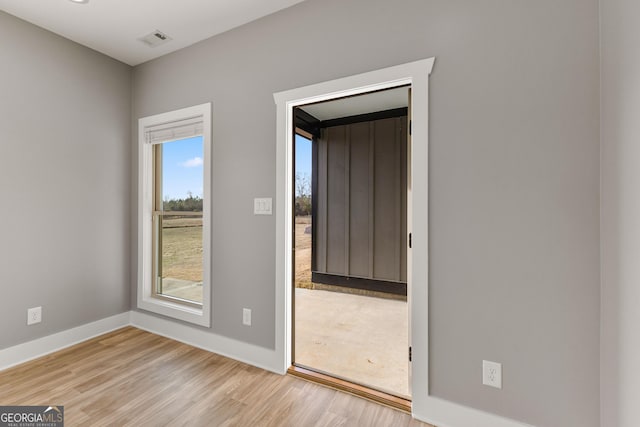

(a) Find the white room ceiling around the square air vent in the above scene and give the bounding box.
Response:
[0,0,303,65]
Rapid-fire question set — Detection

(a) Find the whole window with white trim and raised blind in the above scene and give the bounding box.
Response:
[138,104,211,326]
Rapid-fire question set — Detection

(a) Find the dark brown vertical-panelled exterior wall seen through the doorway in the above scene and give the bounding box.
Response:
[313,117,407,282]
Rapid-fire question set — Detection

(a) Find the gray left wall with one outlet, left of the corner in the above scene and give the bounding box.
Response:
[0,12,131,349]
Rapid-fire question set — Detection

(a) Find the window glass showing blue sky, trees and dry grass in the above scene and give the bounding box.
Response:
[156,137,204,303]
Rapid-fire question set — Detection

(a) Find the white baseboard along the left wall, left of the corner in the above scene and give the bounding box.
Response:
[0,311,130,371]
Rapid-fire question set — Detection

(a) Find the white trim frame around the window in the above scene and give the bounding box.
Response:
[137,103,212,327]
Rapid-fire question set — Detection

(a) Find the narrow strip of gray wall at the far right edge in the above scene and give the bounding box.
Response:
[601,0,640,427]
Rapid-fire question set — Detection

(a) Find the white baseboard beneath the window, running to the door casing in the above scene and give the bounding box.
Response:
[131,311,285,374]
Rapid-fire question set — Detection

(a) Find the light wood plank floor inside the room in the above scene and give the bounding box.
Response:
[0,327,428,427]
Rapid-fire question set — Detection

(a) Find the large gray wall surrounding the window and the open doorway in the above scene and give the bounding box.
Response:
[131,0,600,426]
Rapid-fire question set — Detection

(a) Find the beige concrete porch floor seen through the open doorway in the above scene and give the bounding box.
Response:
[294,288,410,397]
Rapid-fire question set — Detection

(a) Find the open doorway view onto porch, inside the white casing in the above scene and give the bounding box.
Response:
[291,85,411,400]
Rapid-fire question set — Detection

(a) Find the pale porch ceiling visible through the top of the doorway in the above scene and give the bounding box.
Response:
[301,86,409,120]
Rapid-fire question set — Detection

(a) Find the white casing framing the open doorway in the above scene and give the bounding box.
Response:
[274,58,435,414]
